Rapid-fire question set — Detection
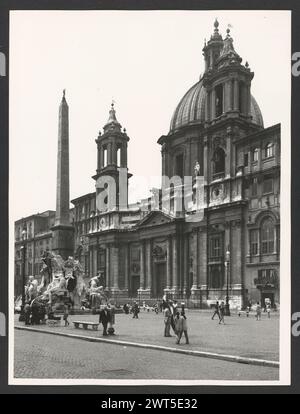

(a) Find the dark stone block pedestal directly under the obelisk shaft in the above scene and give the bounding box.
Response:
[51,224,74,260]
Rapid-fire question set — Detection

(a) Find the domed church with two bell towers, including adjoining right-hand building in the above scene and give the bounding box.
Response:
[72,21,280,307]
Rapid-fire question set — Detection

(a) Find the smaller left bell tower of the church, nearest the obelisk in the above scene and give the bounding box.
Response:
[93,103,131,213]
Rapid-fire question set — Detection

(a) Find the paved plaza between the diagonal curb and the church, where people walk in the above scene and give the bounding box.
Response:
[15,310,279,361]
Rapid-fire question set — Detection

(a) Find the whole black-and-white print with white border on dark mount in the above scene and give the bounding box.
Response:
[9,10,291,386]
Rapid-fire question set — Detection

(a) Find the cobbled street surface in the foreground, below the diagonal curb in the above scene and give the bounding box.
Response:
[14,330,279,381]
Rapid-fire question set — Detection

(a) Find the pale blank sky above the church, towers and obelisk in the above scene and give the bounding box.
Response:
[9,11,291,220]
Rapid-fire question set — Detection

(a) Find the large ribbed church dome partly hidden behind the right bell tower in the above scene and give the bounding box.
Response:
[170,79,264,133]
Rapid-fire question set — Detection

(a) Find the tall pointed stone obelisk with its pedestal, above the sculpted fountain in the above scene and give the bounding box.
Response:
[52,90,74,259]
